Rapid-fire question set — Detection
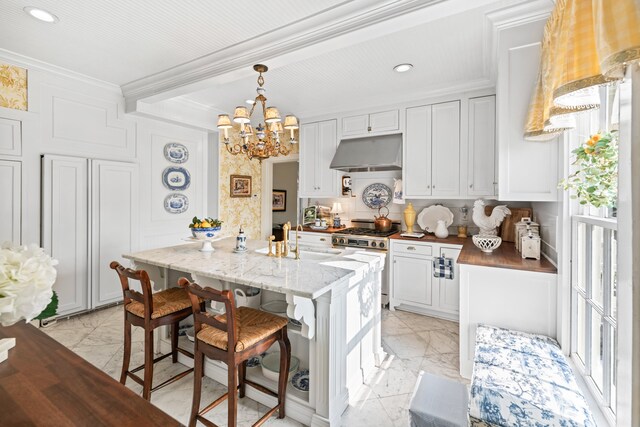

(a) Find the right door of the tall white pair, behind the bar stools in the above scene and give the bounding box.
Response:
[91,160,139,308]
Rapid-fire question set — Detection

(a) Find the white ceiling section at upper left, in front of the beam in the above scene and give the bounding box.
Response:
[0,0,345,85]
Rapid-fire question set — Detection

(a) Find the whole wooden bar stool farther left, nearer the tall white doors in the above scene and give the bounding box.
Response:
[109,261,193,400]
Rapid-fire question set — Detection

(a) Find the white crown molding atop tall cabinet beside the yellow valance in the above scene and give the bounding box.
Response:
[484,0,555,83]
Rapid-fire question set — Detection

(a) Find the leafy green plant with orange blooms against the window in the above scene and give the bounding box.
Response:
[560,132,618,208]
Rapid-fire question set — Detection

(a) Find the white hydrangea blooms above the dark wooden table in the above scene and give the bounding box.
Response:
[0,242,58,326]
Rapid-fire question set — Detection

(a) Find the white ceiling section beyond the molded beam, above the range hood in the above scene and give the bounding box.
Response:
[184,1,513,117]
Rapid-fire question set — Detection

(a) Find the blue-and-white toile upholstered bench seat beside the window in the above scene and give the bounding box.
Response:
[469,325,596,427]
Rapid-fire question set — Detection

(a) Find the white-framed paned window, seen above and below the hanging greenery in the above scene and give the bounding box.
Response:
[570,87,618,421]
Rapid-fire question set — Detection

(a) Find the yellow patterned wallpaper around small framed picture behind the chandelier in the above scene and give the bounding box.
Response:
[218,128,298,239]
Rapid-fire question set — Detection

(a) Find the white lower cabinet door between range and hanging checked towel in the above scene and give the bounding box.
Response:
[393,256,433,305]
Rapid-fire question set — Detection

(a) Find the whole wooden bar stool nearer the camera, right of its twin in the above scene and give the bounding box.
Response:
[178,277,291,427]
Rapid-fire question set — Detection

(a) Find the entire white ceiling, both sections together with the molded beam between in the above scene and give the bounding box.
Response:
[0,0,527,118]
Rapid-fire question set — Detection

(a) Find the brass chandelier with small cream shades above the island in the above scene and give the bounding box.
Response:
[218,64,298,162]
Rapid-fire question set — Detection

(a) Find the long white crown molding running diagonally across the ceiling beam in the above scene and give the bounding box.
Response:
[122,0,458,103]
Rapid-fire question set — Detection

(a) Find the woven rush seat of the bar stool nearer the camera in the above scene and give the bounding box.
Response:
[197,307,289,351]
